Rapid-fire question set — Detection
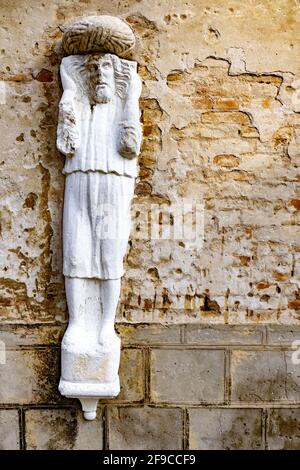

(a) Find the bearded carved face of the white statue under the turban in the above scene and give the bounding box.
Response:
[87,54,115,103]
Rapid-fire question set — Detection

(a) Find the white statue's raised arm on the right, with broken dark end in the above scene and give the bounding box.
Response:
[120,74,142,160]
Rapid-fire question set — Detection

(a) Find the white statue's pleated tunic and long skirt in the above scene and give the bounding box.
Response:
[61,56,140,279]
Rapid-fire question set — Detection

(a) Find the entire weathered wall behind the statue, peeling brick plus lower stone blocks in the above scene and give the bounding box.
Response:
[0,0,300,449]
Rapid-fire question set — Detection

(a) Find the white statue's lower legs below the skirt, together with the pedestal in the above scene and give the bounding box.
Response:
[59,276,120,419]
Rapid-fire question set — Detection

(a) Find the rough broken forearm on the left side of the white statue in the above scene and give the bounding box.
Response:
[56,103,79,157]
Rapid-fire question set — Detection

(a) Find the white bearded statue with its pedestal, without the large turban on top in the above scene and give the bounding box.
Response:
[57,53,141,419]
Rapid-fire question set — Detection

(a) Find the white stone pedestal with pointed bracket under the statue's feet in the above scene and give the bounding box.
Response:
[59,335,121,420]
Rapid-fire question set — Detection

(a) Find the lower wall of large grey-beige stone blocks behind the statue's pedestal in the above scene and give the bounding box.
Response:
[0,323,300,450]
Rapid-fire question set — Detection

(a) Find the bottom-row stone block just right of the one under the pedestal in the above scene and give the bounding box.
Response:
[109,407,183,450]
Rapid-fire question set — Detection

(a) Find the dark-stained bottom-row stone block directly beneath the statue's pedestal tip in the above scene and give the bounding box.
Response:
[25,409,103,450]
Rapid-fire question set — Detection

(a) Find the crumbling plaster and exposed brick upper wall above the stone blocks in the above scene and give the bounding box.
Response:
[0,0,300,323]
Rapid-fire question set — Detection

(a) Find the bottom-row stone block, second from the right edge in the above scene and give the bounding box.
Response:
[189,408,262,450]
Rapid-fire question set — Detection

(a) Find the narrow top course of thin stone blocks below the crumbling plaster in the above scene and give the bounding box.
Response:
[0,322,300,349]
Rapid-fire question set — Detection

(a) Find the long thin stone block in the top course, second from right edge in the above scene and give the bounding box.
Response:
[186,325,263,345]
